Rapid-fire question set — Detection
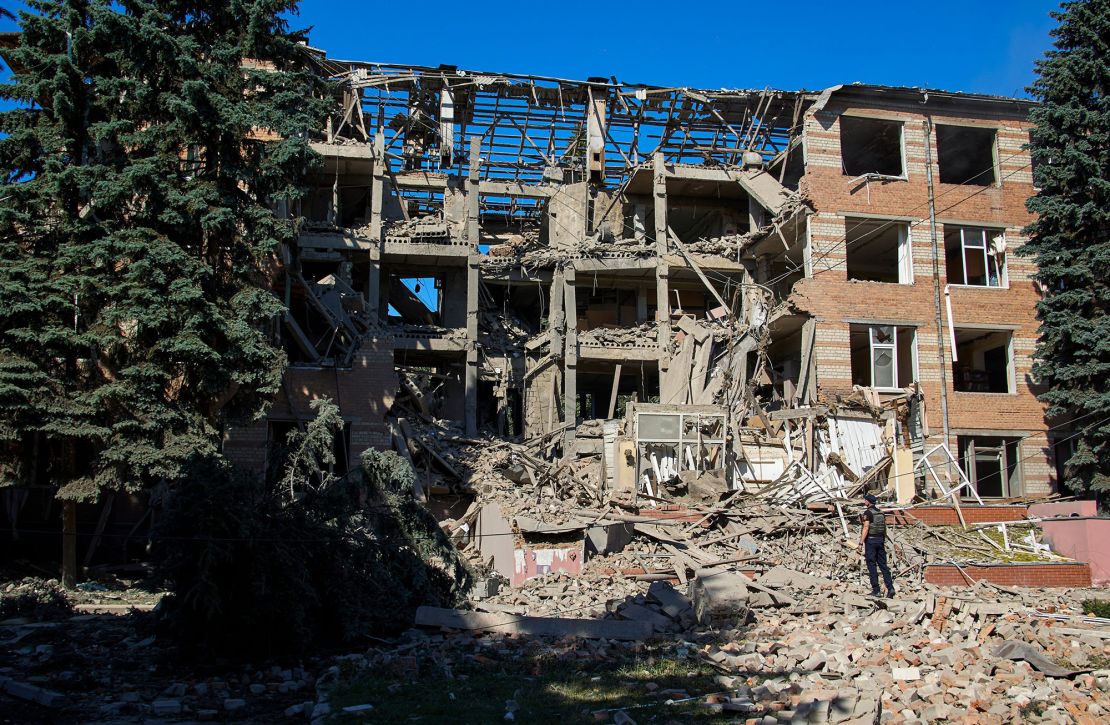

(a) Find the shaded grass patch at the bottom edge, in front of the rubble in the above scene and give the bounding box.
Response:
[330,644,737,725]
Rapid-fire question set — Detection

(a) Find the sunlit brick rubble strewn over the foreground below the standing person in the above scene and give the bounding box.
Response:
[412,566,1110,725]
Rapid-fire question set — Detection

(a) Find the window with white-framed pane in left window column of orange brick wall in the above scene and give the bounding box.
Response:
[849,324,917,391]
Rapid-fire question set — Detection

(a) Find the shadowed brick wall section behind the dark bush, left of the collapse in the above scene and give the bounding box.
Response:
[223,338,398,471]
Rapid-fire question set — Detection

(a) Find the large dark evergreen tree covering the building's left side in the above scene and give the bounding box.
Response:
[0,0,326,500]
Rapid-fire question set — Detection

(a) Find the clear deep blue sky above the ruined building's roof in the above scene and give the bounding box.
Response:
[0,0,1058,95]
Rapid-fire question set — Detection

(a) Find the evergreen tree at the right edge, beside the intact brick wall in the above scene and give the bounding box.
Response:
[1019,0,1110,495]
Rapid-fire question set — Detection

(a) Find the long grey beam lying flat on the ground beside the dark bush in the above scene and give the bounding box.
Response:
[416,606,652,642]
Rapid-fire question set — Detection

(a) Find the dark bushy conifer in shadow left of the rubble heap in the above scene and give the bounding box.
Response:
[155,401,470,657]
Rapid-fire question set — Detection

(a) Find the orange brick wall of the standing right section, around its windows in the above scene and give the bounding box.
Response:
[791,97,1055,495]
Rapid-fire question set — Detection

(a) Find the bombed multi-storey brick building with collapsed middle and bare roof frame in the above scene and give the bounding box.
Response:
[224,53,1055,510]
